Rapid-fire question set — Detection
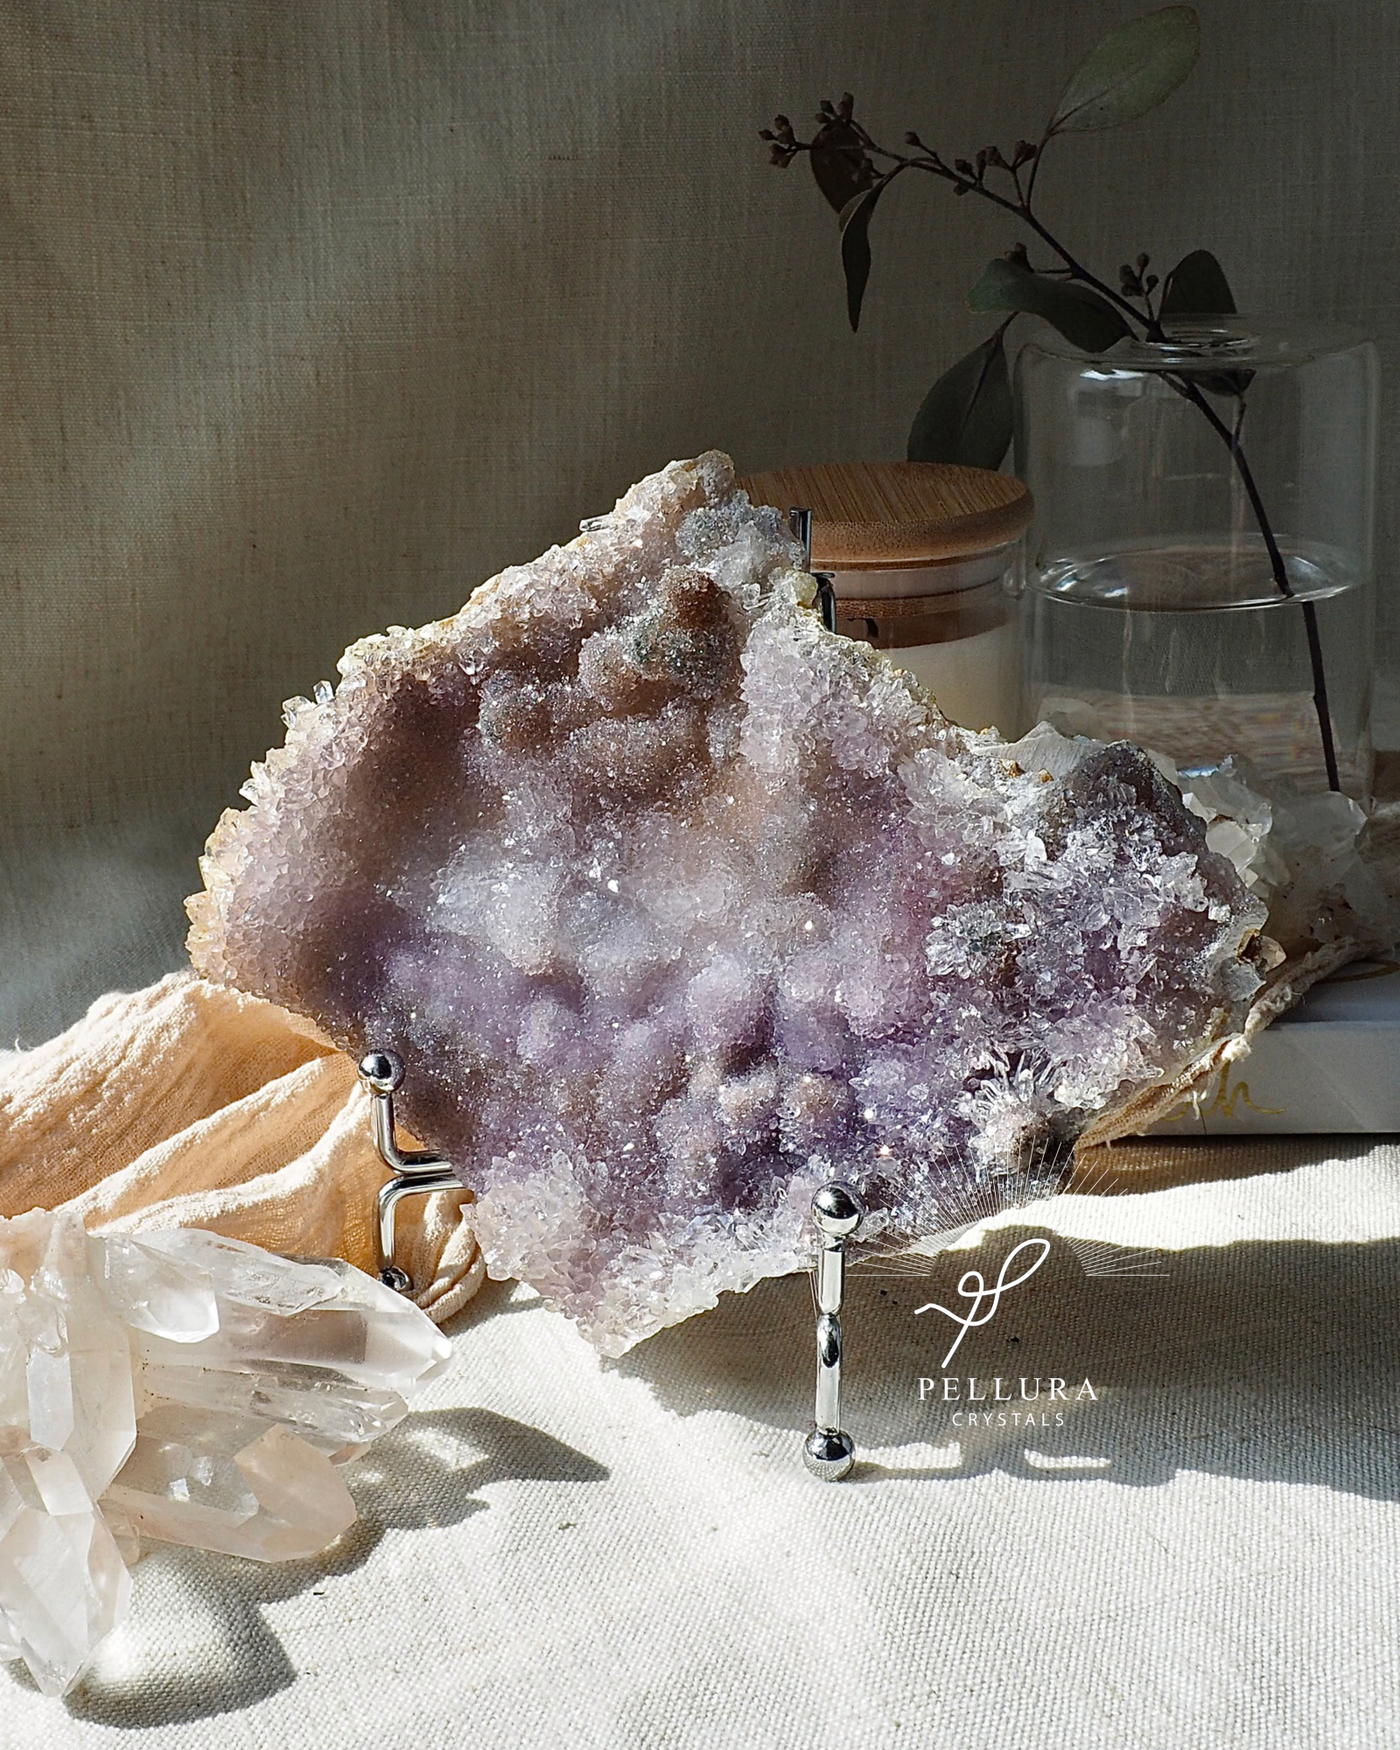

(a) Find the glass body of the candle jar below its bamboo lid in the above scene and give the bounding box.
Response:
[830,541,1020,737]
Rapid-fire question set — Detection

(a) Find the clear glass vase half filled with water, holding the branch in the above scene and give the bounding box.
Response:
[1015,317,1379,803]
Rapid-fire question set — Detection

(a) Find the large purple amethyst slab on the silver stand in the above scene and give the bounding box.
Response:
[189,452,1264,1355]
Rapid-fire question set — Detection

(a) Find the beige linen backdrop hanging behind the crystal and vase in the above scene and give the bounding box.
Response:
[0,0,1400,1043]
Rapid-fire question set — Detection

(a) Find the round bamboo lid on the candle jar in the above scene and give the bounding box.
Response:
[739,462,1034,571]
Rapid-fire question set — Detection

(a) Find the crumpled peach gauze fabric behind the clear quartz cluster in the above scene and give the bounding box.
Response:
[0,973,485,1320]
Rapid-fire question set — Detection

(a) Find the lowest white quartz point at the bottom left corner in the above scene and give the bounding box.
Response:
[0,1446,131,1696]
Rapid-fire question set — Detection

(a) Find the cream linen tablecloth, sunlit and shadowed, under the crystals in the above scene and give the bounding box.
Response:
[0,1139,1400,1750]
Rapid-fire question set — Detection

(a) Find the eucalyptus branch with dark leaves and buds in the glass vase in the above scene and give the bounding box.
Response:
[761,5,1341,789]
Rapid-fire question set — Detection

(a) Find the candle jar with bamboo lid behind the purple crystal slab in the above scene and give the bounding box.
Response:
[740,462,1033,735]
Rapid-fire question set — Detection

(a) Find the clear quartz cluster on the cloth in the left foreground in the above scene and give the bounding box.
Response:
[0,1209,450,1696]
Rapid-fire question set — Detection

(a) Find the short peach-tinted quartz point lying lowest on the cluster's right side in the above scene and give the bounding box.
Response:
[107,1404,355,1561]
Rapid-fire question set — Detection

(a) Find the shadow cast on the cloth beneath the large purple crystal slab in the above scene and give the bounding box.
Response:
[614,1225,1400,1500]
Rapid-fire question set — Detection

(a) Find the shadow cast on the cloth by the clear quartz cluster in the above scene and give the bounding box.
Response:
[46,1409,607,1729]
